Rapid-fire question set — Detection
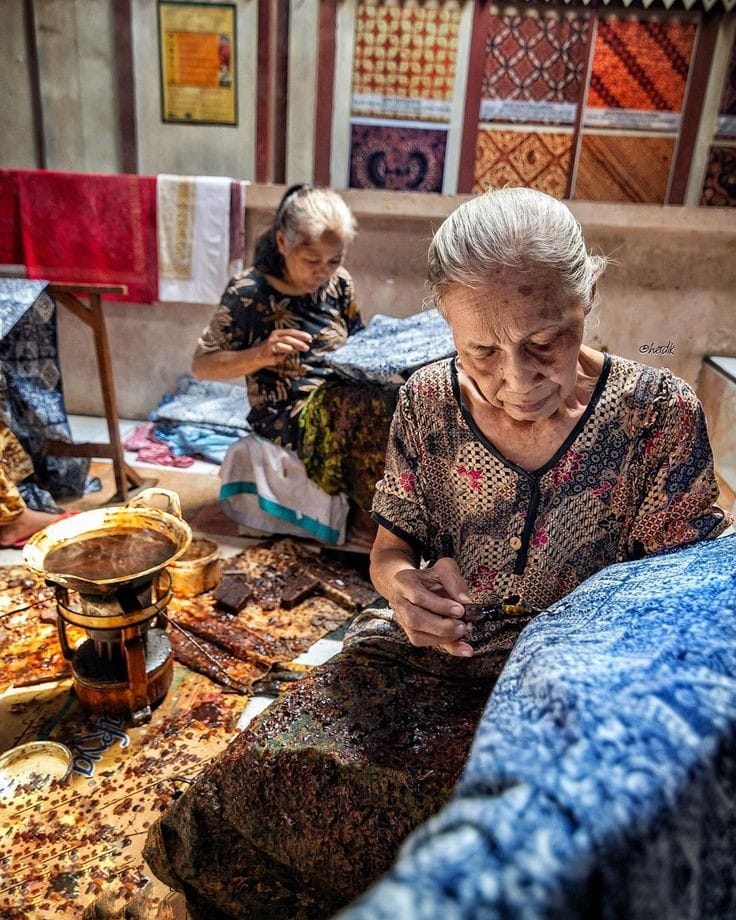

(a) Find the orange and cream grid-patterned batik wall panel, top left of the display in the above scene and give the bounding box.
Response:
[352,2,460,121]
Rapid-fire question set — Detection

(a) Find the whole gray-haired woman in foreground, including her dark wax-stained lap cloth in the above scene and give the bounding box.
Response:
[147,189,729,920]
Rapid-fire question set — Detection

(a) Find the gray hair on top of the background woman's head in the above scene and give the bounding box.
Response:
[277,186,355,246]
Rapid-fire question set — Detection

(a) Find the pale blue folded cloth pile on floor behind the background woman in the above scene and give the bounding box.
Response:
[148,376,251,463]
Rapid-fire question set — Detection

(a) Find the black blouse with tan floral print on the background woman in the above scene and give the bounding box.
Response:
[195,268,363,450]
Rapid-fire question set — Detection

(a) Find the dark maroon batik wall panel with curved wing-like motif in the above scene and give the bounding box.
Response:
[350,124,447,192]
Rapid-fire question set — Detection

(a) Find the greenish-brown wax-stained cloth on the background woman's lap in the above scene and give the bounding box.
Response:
[298,380,398,511]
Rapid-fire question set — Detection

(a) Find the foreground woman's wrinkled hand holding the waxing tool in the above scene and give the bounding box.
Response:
[387,557,473,658]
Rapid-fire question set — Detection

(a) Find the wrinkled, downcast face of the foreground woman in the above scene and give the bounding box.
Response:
[443,274,585,422]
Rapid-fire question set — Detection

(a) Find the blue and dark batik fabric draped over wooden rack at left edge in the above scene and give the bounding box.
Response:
[0,279,96,510]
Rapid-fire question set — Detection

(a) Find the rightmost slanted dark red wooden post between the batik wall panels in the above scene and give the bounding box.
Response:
[665,9,723,204]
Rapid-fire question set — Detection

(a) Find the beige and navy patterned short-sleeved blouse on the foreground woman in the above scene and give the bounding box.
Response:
[373,355,730,608]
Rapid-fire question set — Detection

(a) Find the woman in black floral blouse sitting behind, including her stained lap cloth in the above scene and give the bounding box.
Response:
[192,185,396,541]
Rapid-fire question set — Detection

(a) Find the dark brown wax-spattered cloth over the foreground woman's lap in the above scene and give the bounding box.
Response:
[145,610,529,920]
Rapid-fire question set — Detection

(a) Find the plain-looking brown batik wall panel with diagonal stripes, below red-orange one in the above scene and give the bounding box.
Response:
[574,134,675,204]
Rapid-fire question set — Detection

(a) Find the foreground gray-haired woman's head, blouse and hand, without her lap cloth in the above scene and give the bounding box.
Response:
[371,188,729,656]
